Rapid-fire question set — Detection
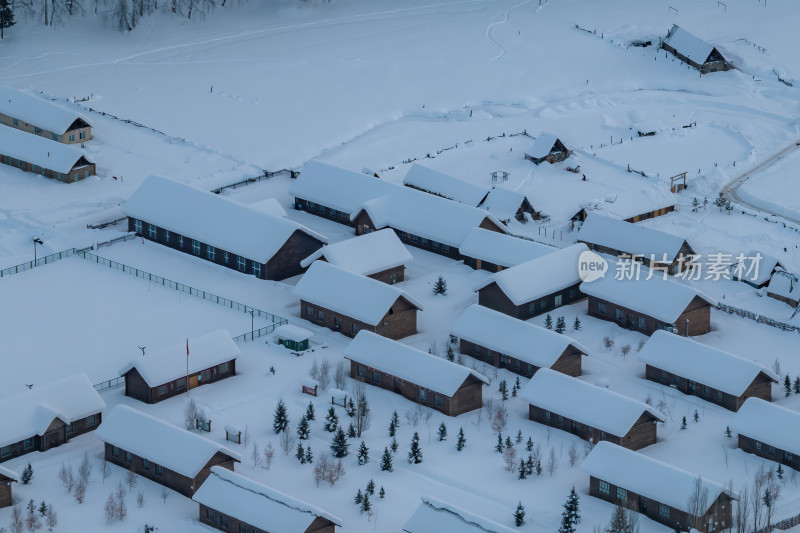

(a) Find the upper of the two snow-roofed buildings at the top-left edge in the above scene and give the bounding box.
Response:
[0,86,94,142]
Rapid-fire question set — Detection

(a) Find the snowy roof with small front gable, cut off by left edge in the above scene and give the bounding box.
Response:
[0,374,106,447]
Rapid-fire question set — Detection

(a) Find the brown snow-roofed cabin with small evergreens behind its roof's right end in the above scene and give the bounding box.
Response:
[451,304,589,378]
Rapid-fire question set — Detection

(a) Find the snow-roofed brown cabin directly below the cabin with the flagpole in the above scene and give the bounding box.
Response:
[95,404,242,498]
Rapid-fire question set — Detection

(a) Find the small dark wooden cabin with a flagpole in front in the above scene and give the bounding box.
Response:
[120,330,241,403]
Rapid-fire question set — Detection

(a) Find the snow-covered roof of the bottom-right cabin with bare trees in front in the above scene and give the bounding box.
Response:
[581,441,738,514]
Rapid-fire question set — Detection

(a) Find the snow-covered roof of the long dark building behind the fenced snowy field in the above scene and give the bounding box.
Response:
[122,176,327,263]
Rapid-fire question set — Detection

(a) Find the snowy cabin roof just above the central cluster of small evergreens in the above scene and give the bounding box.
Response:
[344,330,489,396]
